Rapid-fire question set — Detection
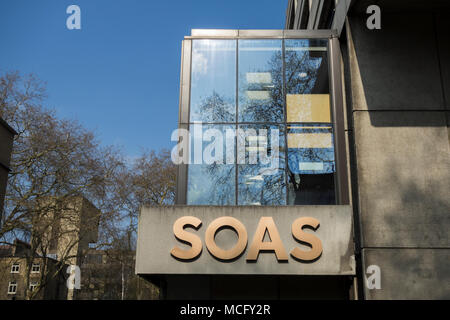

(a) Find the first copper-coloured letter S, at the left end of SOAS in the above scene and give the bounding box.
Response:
[170,216,203,260]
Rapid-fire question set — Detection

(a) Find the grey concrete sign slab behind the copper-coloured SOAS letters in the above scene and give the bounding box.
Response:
[136,206,355,275]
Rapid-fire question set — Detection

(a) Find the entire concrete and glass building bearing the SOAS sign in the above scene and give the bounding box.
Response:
[136,0,450,299]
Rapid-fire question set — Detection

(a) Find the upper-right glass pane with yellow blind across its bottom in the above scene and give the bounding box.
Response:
[285,39,331,123]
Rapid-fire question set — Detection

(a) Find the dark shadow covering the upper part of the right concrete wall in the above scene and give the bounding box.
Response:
[341,6,450,127]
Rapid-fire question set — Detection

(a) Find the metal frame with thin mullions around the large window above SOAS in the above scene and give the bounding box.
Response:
[175,29,349,205]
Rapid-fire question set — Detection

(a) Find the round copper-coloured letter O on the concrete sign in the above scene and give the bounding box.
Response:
[205,217,247,260]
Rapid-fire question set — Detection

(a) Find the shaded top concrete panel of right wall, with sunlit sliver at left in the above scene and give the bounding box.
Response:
[349,13,448,110]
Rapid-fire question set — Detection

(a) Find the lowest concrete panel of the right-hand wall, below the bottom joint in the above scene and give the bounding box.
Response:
[363,249,450,300]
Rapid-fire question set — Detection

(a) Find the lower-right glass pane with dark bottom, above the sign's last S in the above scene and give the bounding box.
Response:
[287,124,336,205]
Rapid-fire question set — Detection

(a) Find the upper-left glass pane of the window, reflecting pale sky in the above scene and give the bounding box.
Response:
[190,40,236,122]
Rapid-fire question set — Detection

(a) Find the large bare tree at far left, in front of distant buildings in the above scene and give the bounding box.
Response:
[0,73,125,298]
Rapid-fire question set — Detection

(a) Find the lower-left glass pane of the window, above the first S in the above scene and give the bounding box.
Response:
[187,124,236,205]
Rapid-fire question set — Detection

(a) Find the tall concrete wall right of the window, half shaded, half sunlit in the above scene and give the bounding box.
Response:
[341,4,450,299]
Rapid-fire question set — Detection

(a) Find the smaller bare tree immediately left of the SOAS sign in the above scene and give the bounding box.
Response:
[77,150,176,300]
